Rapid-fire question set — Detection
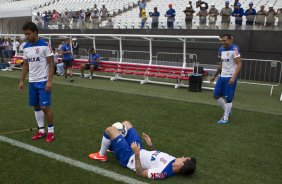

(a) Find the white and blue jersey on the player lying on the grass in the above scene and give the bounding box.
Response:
[127,149,175,179]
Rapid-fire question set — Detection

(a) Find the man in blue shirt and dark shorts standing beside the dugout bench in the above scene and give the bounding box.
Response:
[62,38,73,82]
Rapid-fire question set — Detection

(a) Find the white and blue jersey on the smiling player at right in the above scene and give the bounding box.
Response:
[218,44,241,77]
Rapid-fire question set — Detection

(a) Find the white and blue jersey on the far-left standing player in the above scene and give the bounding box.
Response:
[23,39,54,82]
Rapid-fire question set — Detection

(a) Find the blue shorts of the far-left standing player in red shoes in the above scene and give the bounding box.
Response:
[29,81,51,107]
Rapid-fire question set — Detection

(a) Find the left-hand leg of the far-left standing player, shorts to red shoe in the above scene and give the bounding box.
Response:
[29,83,46,140]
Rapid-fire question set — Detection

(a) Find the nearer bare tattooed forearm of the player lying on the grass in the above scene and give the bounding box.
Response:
[131,142,148,178]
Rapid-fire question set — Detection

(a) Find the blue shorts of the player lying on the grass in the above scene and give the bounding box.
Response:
[111,128,143,167]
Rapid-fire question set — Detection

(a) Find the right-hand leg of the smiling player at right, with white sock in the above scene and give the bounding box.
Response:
[223,78,237,121]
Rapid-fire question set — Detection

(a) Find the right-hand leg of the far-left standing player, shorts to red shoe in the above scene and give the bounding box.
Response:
[37,82,55,142]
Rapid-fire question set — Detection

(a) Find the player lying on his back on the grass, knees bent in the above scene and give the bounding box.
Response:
[89,121,196,179]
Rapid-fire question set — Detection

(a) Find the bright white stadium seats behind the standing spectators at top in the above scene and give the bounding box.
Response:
[114,0,282,29]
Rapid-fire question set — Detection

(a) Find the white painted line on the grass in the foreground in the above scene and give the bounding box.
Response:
[0,135,147,184]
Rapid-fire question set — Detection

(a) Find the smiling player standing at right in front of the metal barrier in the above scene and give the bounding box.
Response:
[210,34,242,124]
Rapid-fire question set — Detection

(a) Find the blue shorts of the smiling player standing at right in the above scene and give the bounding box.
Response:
[213,77,237,103]
